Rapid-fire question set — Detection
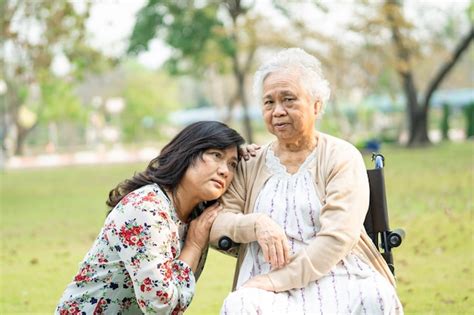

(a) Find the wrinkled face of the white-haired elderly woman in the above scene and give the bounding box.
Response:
[262,71,319,142]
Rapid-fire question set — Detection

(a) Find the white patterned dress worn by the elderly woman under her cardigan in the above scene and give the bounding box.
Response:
[221,149,403,314]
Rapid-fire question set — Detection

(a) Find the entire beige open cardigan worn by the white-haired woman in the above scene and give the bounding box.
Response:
[210,132,395,292]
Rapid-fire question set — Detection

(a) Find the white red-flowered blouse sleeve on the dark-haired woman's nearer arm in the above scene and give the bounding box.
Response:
[107,192,195,314]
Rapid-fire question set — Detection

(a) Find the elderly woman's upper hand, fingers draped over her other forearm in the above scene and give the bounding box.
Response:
[255,216,290,269]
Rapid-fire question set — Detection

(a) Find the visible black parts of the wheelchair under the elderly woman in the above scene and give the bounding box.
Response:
[217,153,405,274]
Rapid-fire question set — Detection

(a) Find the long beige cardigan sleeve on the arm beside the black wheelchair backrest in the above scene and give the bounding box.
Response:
[267,143,369,292]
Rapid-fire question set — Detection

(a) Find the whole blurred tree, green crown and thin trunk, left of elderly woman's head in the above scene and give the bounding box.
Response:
[129,0,257,142]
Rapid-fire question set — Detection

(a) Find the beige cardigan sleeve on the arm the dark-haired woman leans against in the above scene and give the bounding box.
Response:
[210,157,263,247]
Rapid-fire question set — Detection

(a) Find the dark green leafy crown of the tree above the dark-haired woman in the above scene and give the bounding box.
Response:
[128,0,235,74]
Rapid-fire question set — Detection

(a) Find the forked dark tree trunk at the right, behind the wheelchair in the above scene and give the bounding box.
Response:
[382,0,474,146]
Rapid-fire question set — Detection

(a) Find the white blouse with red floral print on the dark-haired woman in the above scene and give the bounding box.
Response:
[56,184,195,314]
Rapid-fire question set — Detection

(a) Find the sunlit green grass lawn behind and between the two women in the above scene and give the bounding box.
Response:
[0,142,474,315]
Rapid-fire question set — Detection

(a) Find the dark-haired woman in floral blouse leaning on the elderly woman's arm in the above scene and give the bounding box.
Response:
[56,121,244,314]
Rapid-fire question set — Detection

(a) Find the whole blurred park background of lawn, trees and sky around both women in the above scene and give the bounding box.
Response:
[0,0,474,314]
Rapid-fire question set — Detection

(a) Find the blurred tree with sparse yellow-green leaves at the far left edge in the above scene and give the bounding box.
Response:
[0,0,106,155]
